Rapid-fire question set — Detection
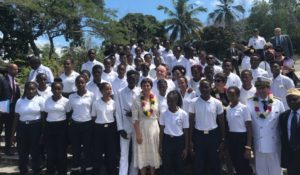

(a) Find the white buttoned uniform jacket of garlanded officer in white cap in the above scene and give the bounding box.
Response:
[247,98,284,153]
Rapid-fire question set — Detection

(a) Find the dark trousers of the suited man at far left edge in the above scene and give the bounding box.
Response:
[0,113,15,151]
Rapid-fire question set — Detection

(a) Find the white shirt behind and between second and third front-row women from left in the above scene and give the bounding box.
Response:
[59,71,79,93]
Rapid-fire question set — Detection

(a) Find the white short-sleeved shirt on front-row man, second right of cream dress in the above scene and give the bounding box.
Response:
[189,97,223,131]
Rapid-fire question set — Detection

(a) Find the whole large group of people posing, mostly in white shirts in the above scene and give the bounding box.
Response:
[0,28,300,175]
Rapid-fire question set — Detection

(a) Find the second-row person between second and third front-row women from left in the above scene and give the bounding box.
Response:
[59,58,79,98]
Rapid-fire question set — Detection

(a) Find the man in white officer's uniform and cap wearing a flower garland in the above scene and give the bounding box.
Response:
[247,77,284,175]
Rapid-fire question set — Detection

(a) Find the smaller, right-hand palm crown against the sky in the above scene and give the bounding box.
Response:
[208,0,245,28]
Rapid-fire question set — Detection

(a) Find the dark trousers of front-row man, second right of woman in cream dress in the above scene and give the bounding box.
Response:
[193,128,221,175]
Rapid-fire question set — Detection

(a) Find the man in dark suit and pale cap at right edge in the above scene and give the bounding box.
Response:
[279,88,300,175]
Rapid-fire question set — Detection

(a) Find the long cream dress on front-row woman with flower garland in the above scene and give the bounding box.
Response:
[132,95,161,169]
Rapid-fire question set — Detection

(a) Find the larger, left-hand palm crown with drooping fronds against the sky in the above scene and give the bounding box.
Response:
[157,0,206,42]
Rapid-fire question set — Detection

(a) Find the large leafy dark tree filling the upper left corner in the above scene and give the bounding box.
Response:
[0,0,109,58]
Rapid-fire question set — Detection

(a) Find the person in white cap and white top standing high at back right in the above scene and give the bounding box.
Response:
[248,29,266,58]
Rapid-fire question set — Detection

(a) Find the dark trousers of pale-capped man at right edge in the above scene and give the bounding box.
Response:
[287,150,300,175]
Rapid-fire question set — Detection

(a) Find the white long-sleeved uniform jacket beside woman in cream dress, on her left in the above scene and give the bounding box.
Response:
[115,87,141,133]
